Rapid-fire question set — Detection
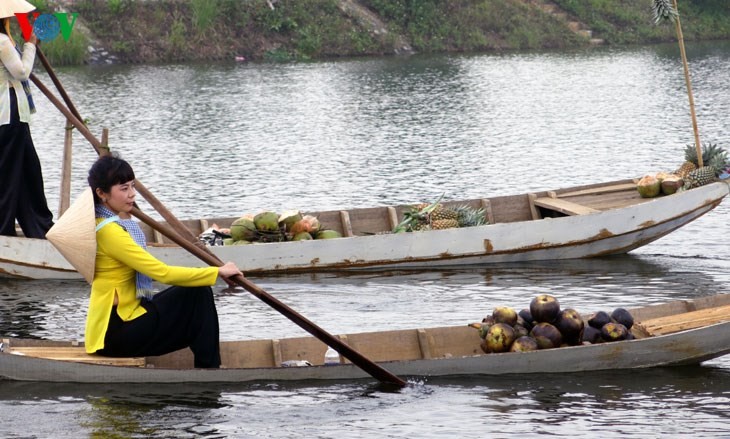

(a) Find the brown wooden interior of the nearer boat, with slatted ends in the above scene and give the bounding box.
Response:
[2,294,730,369]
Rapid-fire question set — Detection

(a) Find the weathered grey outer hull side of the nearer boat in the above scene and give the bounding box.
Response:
[0,322,730,383]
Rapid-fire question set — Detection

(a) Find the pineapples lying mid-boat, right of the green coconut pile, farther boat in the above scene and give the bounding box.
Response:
[393,201,487,233]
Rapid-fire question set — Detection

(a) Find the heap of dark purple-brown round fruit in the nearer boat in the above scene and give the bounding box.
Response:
[469,294,634,353]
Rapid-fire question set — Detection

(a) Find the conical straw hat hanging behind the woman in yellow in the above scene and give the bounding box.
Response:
[46,188,96,283]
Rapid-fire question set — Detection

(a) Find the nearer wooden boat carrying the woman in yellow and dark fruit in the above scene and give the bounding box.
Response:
[0,294,730,383]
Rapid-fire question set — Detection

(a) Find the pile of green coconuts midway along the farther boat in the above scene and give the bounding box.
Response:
[199,210,342,245]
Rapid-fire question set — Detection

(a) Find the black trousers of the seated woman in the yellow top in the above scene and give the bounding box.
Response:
[97,287,221,368]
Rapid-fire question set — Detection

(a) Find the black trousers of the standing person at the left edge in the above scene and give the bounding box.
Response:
[0,90,53,238]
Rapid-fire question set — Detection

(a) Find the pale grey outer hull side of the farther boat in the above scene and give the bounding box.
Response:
[0,182,728,279]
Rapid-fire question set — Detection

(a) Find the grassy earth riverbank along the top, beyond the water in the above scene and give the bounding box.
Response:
[35,0,730,64]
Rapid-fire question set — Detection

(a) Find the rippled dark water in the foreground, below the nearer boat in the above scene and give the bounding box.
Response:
[0,367,730,438]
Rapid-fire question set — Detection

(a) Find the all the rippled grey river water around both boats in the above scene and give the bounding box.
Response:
[0,42,730,438]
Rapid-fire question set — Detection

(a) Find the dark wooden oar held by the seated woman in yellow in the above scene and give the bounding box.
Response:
[132,207,406,387]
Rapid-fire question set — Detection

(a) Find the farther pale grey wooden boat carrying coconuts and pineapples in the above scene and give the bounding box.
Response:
[0,180,728,279]
